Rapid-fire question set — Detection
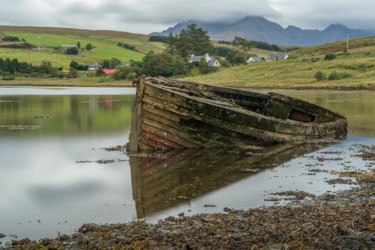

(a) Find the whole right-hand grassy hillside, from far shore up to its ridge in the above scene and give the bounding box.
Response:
[185,37,375,89]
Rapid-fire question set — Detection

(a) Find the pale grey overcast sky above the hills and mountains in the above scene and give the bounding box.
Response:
[0,0,375,34]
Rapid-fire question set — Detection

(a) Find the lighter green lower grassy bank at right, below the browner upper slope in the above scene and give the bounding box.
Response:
[185,56,375,90]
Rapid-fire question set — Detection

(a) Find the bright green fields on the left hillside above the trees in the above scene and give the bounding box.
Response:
[0,26,165,69]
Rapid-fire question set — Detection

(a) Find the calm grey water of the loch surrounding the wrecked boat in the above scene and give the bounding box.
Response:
[0,87,375,243]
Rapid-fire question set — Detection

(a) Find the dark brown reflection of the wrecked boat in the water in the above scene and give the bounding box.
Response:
[130,144,330,218]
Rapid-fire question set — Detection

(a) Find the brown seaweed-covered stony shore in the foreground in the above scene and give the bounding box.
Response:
[0,172,375,249]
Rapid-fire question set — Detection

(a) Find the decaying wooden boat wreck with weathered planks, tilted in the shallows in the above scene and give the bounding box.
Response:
[128,77,347,152]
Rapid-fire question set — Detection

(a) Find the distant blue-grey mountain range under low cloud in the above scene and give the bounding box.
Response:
[150,16,375,46]
